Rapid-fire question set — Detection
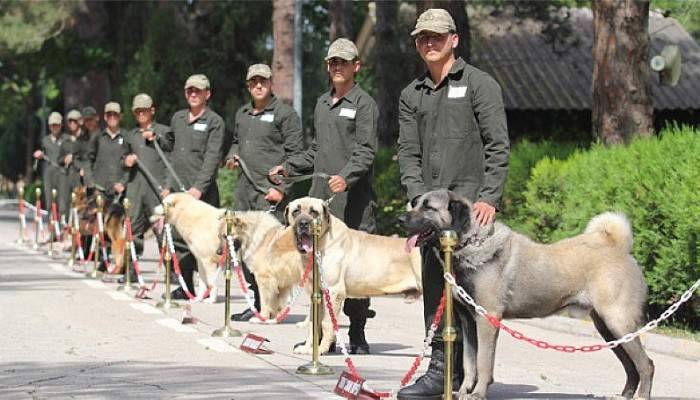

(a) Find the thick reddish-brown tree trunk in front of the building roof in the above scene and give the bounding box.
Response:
[592,0,654,144]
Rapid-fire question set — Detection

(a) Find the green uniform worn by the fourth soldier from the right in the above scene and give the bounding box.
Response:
[168,108,225,293]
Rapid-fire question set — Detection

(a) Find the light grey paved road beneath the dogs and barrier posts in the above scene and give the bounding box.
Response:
[0,213,700,399]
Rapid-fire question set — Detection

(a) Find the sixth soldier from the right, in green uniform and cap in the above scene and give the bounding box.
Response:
[85,102,128,200]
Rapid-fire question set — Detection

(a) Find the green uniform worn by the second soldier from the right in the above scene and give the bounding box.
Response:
[283,85,379,233]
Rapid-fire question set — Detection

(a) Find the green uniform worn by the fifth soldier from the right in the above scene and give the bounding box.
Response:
[124,122,175,253]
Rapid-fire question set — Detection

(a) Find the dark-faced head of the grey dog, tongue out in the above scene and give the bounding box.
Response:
[399,190,473,251]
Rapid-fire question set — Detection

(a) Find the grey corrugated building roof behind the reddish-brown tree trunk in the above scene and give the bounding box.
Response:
[472,9,700,110]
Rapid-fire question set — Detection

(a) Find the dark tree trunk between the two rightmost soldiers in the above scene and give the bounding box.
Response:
[374,0,403,147]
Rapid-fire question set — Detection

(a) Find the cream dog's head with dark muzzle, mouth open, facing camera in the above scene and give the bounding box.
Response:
[284,197,331,253]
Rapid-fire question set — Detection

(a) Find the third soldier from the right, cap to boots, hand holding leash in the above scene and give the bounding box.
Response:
[226,64,304,321]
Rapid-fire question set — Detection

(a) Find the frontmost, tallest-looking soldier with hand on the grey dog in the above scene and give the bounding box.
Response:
[397,9,509,400]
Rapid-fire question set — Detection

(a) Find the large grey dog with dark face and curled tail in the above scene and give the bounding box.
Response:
[402,190,654,400]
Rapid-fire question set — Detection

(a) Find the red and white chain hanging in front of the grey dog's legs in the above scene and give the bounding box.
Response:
[444,274,700,353]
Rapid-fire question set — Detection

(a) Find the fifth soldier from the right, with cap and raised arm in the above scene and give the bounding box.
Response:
[124,93,175,260]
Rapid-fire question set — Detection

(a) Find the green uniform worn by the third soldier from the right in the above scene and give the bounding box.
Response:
[226,95,304,217]
